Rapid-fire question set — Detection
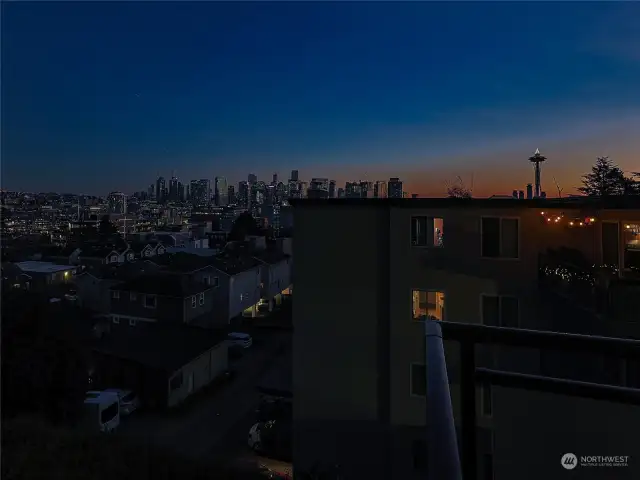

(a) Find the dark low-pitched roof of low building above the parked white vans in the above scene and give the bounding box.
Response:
[94,325,226,372]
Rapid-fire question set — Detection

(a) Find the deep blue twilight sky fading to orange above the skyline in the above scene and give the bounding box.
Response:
[1,2,640,196]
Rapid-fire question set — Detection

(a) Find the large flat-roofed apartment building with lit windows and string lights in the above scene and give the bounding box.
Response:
[293,199,640,479]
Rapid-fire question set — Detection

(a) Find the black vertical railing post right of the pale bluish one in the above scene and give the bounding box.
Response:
[460,340,478,480]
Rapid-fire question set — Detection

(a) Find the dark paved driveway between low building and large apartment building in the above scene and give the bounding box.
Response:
[120,333,291,459]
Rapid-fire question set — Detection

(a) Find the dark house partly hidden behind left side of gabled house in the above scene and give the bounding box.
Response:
[75,260,159,315]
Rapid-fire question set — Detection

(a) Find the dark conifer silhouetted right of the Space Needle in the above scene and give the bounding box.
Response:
[578,157,640,197]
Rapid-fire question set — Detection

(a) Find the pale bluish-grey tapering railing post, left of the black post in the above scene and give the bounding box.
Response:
[425,320,462,480]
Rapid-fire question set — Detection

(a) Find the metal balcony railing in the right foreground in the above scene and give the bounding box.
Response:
[425,321,640,480]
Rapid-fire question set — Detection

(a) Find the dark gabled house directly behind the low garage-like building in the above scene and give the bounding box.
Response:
[110,272,215,328]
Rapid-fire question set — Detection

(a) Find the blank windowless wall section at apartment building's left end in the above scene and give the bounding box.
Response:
[293,207,389,478]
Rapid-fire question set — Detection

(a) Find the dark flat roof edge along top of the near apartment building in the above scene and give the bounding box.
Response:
[290,196,640,210]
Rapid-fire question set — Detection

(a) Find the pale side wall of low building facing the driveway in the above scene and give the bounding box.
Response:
[167,342,229,407]
